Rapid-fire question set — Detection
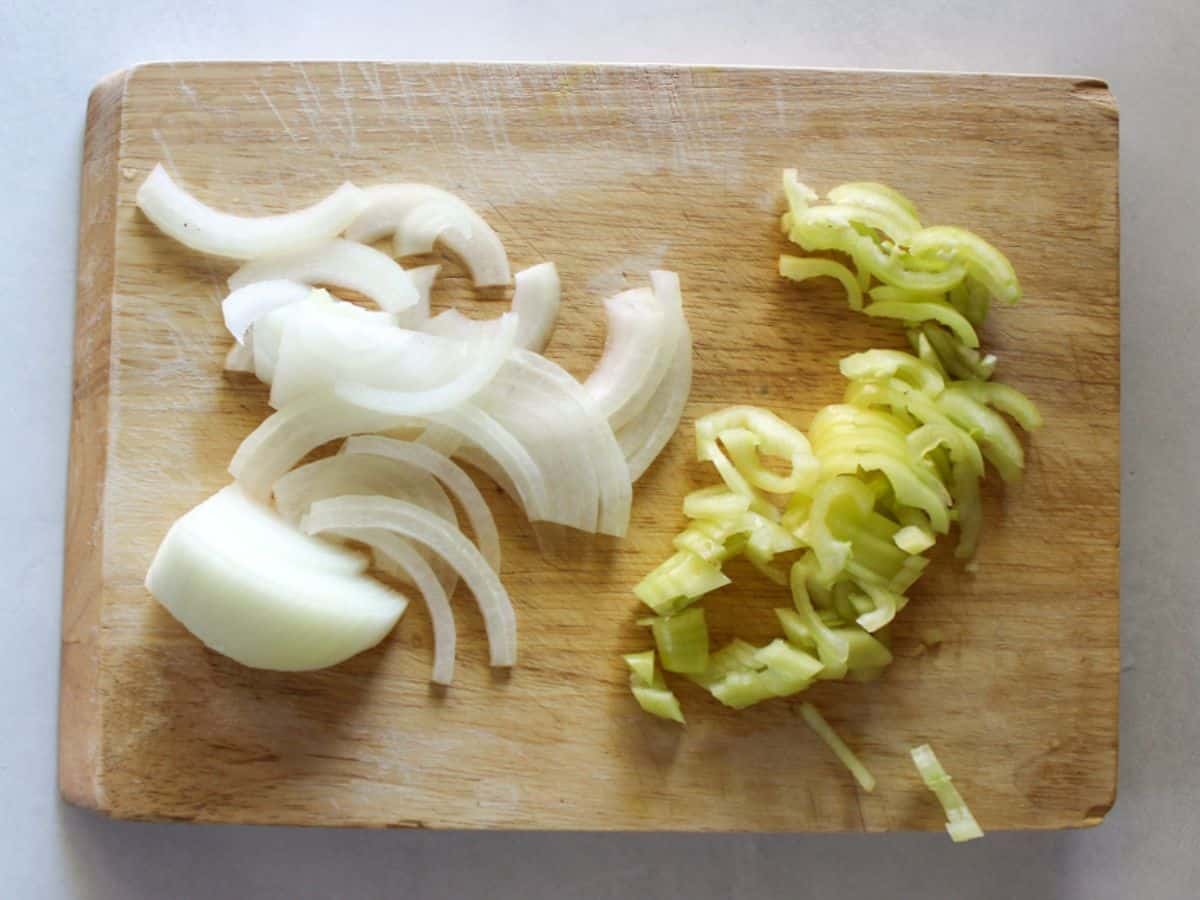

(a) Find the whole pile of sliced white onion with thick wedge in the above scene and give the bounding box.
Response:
[138,166,691,684]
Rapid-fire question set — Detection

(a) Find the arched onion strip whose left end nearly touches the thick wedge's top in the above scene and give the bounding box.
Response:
[229,391,402,498]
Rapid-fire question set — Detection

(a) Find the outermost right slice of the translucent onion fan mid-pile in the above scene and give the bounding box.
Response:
[511,350,634,538]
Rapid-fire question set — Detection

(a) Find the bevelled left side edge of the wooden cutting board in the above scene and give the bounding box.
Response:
[58,68,133,811]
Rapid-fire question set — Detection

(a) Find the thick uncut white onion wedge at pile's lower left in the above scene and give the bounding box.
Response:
[146,488,408,672]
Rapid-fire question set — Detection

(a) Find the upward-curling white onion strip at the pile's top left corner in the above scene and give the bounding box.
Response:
[137,164,367,259]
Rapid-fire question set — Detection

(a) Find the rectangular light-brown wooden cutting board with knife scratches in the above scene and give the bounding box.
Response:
[60,62,1120,830]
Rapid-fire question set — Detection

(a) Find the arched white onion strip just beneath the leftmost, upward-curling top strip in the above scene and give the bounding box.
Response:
[229,238,420,312]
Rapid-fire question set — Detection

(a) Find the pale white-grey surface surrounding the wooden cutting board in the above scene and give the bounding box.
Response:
[0,0,1200,900]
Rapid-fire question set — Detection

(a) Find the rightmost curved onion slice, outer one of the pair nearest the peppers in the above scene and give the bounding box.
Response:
[617,271,691,481]
